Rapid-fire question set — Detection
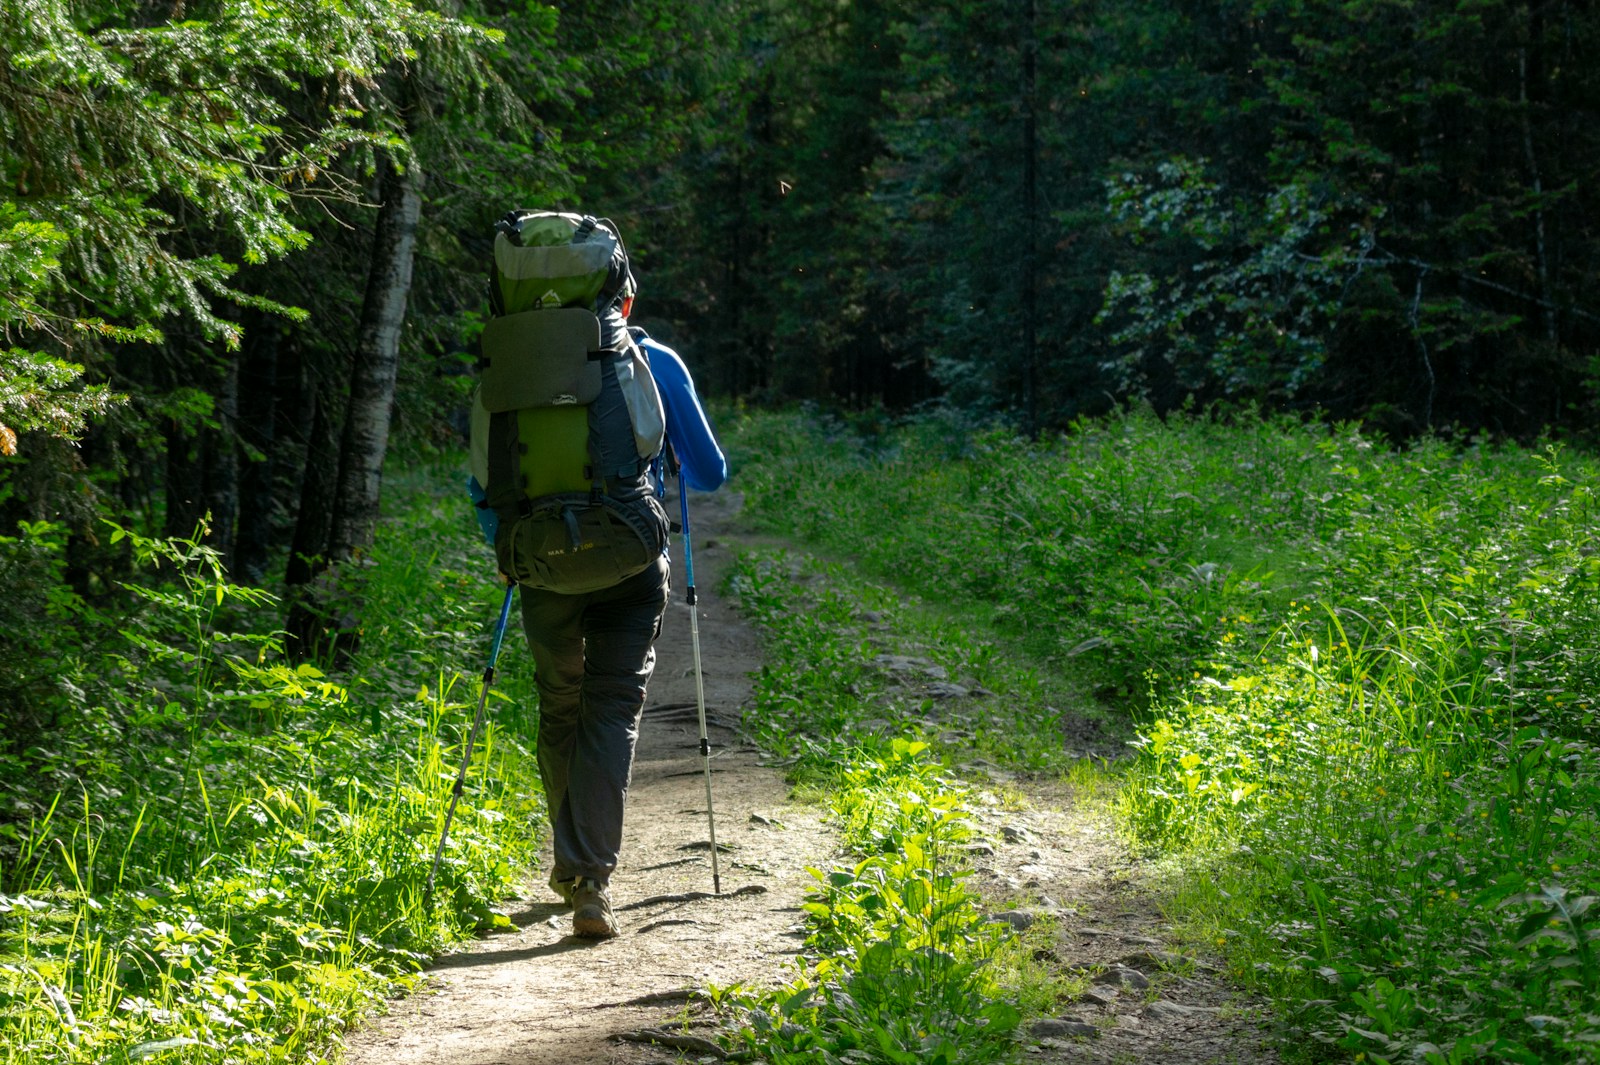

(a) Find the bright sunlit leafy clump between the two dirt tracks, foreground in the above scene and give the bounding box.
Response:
[718,740,1021,1065]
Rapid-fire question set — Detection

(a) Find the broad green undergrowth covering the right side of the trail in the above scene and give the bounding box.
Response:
[725,402,1600,1063]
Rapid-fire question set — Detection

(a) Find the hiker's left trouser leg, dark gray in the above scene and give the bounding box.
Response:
[522,587,587,881]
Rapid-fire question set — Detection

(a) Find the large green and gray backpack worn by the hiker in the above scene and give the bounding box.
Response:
[470,211,669,595]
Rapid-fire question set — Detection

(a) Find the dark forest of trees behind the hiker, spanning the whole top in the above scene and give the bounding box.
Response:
[0,0,1600,655]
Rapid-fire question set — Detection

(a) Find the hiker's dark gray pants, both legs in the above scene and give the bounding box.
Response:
[522,558,670,883]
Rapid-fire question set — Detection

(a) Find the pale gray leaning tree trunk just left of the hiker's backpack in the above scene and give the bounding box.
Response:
[328,160,422,561]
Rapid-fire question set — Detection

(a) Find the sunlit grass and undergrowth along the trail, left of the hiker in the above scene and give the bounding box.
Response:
[0,469,544,1065]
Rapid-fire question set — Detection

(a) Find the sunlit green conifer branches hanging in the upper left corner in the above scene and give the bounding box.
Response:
[0,0,486,447]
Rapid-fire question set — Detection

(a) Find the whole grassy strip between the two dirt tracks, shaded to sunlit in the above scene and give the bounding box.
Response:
[714,553,1021,1065]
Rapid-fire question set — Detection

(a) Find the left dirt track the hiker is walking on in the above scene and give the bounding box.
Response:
[346,494,835,1065]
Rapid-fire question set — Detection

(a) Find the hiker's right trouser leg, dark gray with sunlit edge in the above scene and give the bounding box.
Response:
[563,558,669,884]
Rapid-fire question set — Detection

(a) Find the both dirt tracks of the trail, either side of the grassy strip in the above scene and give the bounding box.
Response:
[346,491,1275,1065]
